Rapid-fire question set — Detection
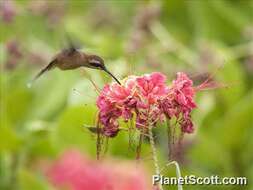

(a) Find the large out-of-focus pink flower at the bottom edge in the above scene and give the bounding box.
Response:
[47,150,152,190]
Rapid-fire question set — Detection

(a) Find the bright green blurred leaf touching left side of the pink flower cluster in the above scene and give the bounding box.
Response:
[53,105,96,155]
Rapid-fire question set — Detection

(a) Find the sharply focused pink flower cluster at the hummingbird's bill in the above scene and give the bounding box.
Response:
[97,72,196,137]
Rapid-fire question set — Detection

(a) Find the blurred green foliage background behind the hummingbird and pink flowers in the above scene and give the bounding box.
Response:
[0,0,253,190]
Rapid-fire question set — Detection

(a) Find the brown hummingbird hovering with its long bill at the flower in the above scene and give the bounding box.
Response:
[29,46,121,86]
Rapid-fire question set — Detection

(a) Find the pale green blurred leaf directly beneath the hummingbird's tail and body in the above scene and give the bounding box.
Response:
[30,71,76,119]
